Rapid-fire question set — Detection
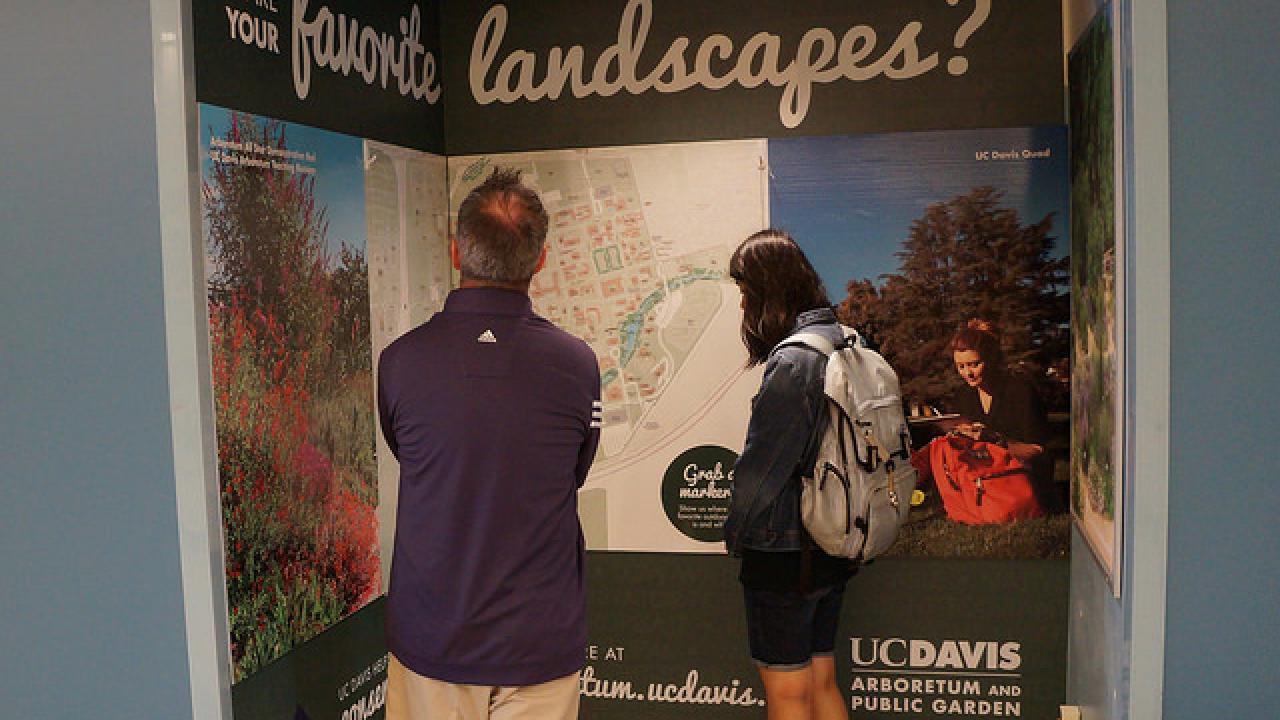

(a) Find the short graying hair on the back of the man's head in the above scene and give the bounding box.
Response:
[457,168,548,283]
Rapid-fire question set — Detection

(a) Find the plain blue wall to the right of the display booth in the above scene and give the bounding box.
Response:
[1165,0,1280,720]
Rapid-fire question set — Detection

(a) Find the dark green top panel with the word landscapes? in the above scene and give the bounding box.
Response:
[442,0,1064,155]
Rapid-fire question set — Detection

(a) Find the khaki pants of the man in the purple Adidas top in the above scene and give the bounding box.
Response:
[387,655,579,720]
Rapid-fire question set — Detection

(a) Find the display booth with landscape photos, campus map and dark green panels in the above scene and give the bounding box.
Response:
[192,0,1090,720]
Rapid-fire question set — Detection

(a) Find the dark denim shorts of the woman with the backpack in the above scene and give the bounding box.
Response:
[742,583,845,670]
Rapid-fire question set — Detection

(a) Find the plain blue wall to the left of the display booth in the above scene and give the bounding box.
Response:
[0,0,191,719]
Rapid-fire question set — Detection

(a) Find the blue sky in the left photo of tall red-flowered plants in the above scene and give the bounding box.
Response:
[200,104,367,263]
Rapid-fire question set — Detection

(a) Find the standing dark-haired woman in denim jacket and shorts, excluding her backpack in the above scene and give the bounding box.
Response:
[724,229,854,720]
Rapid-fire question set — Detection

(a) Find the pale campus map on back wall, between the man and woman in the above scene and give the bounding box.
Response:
[449,140,768,552]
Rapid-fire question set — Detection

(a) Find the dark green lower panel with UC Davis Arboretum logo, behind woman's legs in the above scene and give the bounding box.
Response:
[582,552,1069,720]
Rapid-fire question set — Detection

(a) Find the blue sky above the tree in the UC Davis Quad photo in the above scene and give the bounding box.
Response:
[769,126,1070,297]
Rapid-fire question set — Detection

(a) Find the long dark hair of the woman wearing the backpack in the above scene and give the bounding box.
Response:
[728,228,831,365]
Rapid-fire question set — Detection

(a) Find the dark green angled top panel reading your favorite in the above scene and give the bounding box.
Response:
[192,0,444,152]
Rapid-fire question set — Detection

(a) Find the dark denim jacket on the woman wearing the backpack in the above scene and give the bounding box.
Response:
[724,307,844,555]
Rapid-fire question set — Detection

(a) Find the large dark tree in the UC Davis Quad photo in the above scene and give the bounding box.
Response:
[838,187,1069,406]
